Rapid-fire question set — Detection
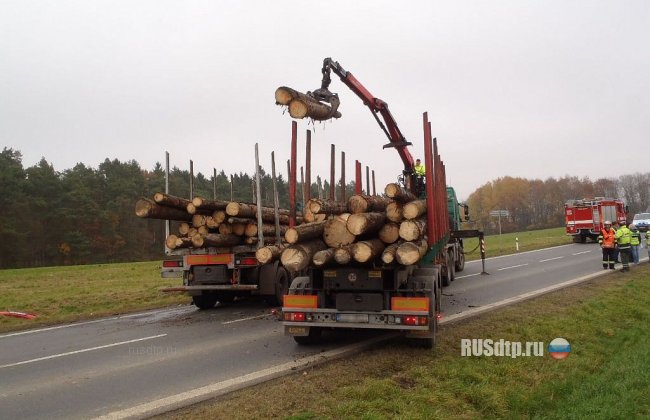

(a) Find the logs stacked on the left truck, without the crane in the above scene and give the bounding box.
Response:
[135,192,298,251]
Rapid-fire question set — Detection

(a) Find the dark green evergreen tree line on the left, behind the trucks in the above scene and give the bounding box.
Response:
[0,147,354,268]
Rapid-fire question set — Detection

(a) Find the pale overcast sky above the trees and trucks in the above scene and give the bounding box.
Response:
[0,0,650,198]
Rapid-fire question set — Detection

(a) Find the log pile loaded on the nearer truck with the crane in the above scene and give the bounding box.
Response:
[257,193,428,272]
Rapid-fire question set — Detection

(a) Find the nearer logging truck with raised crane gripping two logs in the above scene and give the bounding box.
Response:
[276,58,484,348]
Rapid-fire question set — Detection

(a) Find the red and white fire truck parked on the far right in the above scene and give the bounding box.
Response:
[564,197,627,243]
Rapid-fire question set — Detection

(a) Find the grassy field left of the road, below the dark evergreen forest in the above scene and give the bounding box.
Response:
[0,261,189,331]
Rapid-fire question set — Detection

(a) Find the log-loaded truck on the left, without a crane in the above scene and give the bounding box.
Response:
[136,156,291,309]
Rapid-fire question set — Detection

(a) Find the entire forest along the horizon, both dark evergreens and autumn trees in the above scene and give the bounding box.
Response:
[0,148,650,268]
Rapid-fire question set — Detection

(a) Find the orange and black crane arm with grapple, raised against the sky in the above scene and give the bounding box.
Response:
[311,58,415,174]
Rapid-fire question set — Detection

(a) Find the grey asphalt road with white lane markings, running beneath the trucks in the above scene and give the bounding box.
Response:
[0,244,616,419]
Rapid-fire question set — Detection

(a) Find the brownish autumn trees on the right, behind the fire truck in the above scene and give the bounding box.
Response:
[467,173,650,233]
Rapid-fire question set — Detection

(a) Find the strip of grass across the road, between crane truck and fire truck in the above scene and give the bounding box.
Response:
[464,227,572,260]
